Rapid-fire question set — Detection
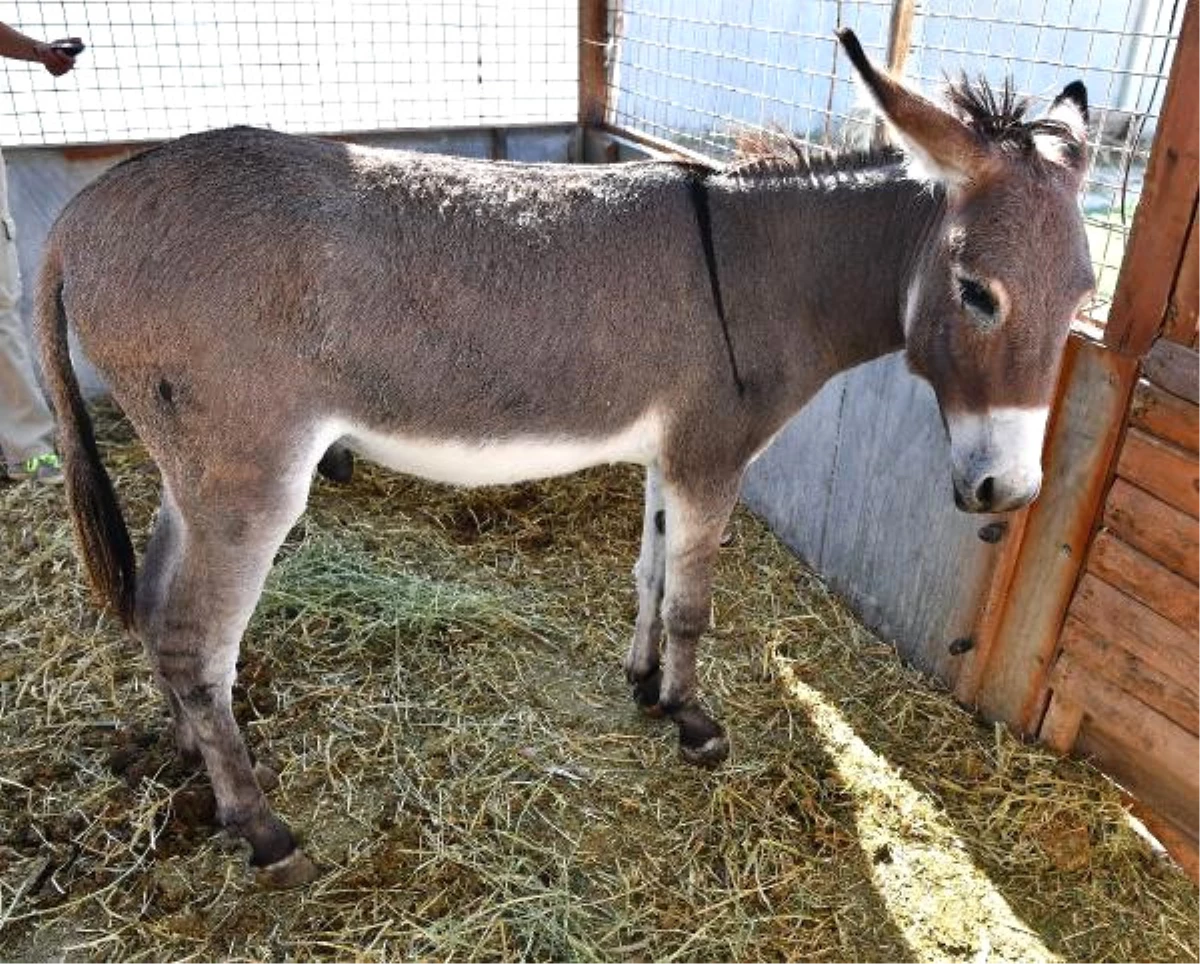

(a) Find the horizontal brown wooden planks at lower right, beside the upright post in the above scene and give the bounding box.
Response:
[1039,357,1200,872]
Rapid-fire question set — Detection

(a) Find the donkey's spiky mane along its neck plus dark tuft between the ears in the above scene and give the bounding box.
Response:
[725,74,1080,176]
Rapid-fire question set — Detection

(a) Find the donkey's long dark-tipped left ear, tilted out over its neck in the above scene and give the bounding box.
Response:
[838,29,995,187]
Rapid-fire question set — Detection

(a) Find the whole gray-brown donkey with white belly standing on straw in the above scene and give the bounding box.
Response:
[36,31,1093,886]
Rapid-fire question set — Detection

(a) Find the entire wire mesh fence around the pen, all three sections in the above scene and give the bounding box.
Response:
[0,0,1182,322]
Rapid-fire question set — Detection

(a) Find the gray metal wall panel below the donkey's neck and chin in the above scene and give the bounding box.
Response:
[743,354,1000,681]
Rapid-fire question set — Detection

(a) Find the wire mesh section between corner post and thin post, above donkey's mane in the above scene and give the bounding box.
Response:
[608,0,893,157]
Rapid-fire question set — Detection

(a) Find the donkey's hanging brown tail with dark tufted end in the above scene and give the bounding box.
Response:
[34,244,137,629]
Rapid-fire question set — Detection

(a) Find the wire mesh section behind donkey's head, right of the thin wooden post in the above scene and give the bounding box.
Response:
[906,0,1183,324]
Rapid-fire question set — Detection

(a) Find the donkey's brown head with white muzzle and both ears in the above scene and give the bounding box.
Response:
[840,31,1094,511]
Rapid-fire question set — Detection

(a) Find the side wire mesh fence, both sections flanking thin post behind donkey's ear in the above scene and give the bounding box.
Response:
[608,0,1182,324]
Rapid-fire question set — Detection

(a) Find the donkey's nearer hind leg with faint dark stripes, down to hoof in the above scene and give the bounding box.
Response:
[143,472,316,886]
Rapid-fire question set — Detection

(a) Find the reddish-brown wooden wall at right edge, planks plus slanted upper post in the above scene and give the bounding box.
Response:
[1022,0,1200,880]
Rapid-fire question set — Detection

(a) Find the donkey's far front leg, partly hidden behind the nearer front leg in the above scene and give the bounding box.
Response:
[625,465,667,715]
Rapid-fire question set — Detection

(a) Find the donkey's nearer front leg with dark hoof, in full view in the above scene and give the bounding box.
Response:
[659,479,738,766]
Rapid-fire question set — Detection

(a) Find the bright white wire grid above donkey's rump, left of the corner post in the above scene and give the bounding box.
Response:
[0,0,578,145]
